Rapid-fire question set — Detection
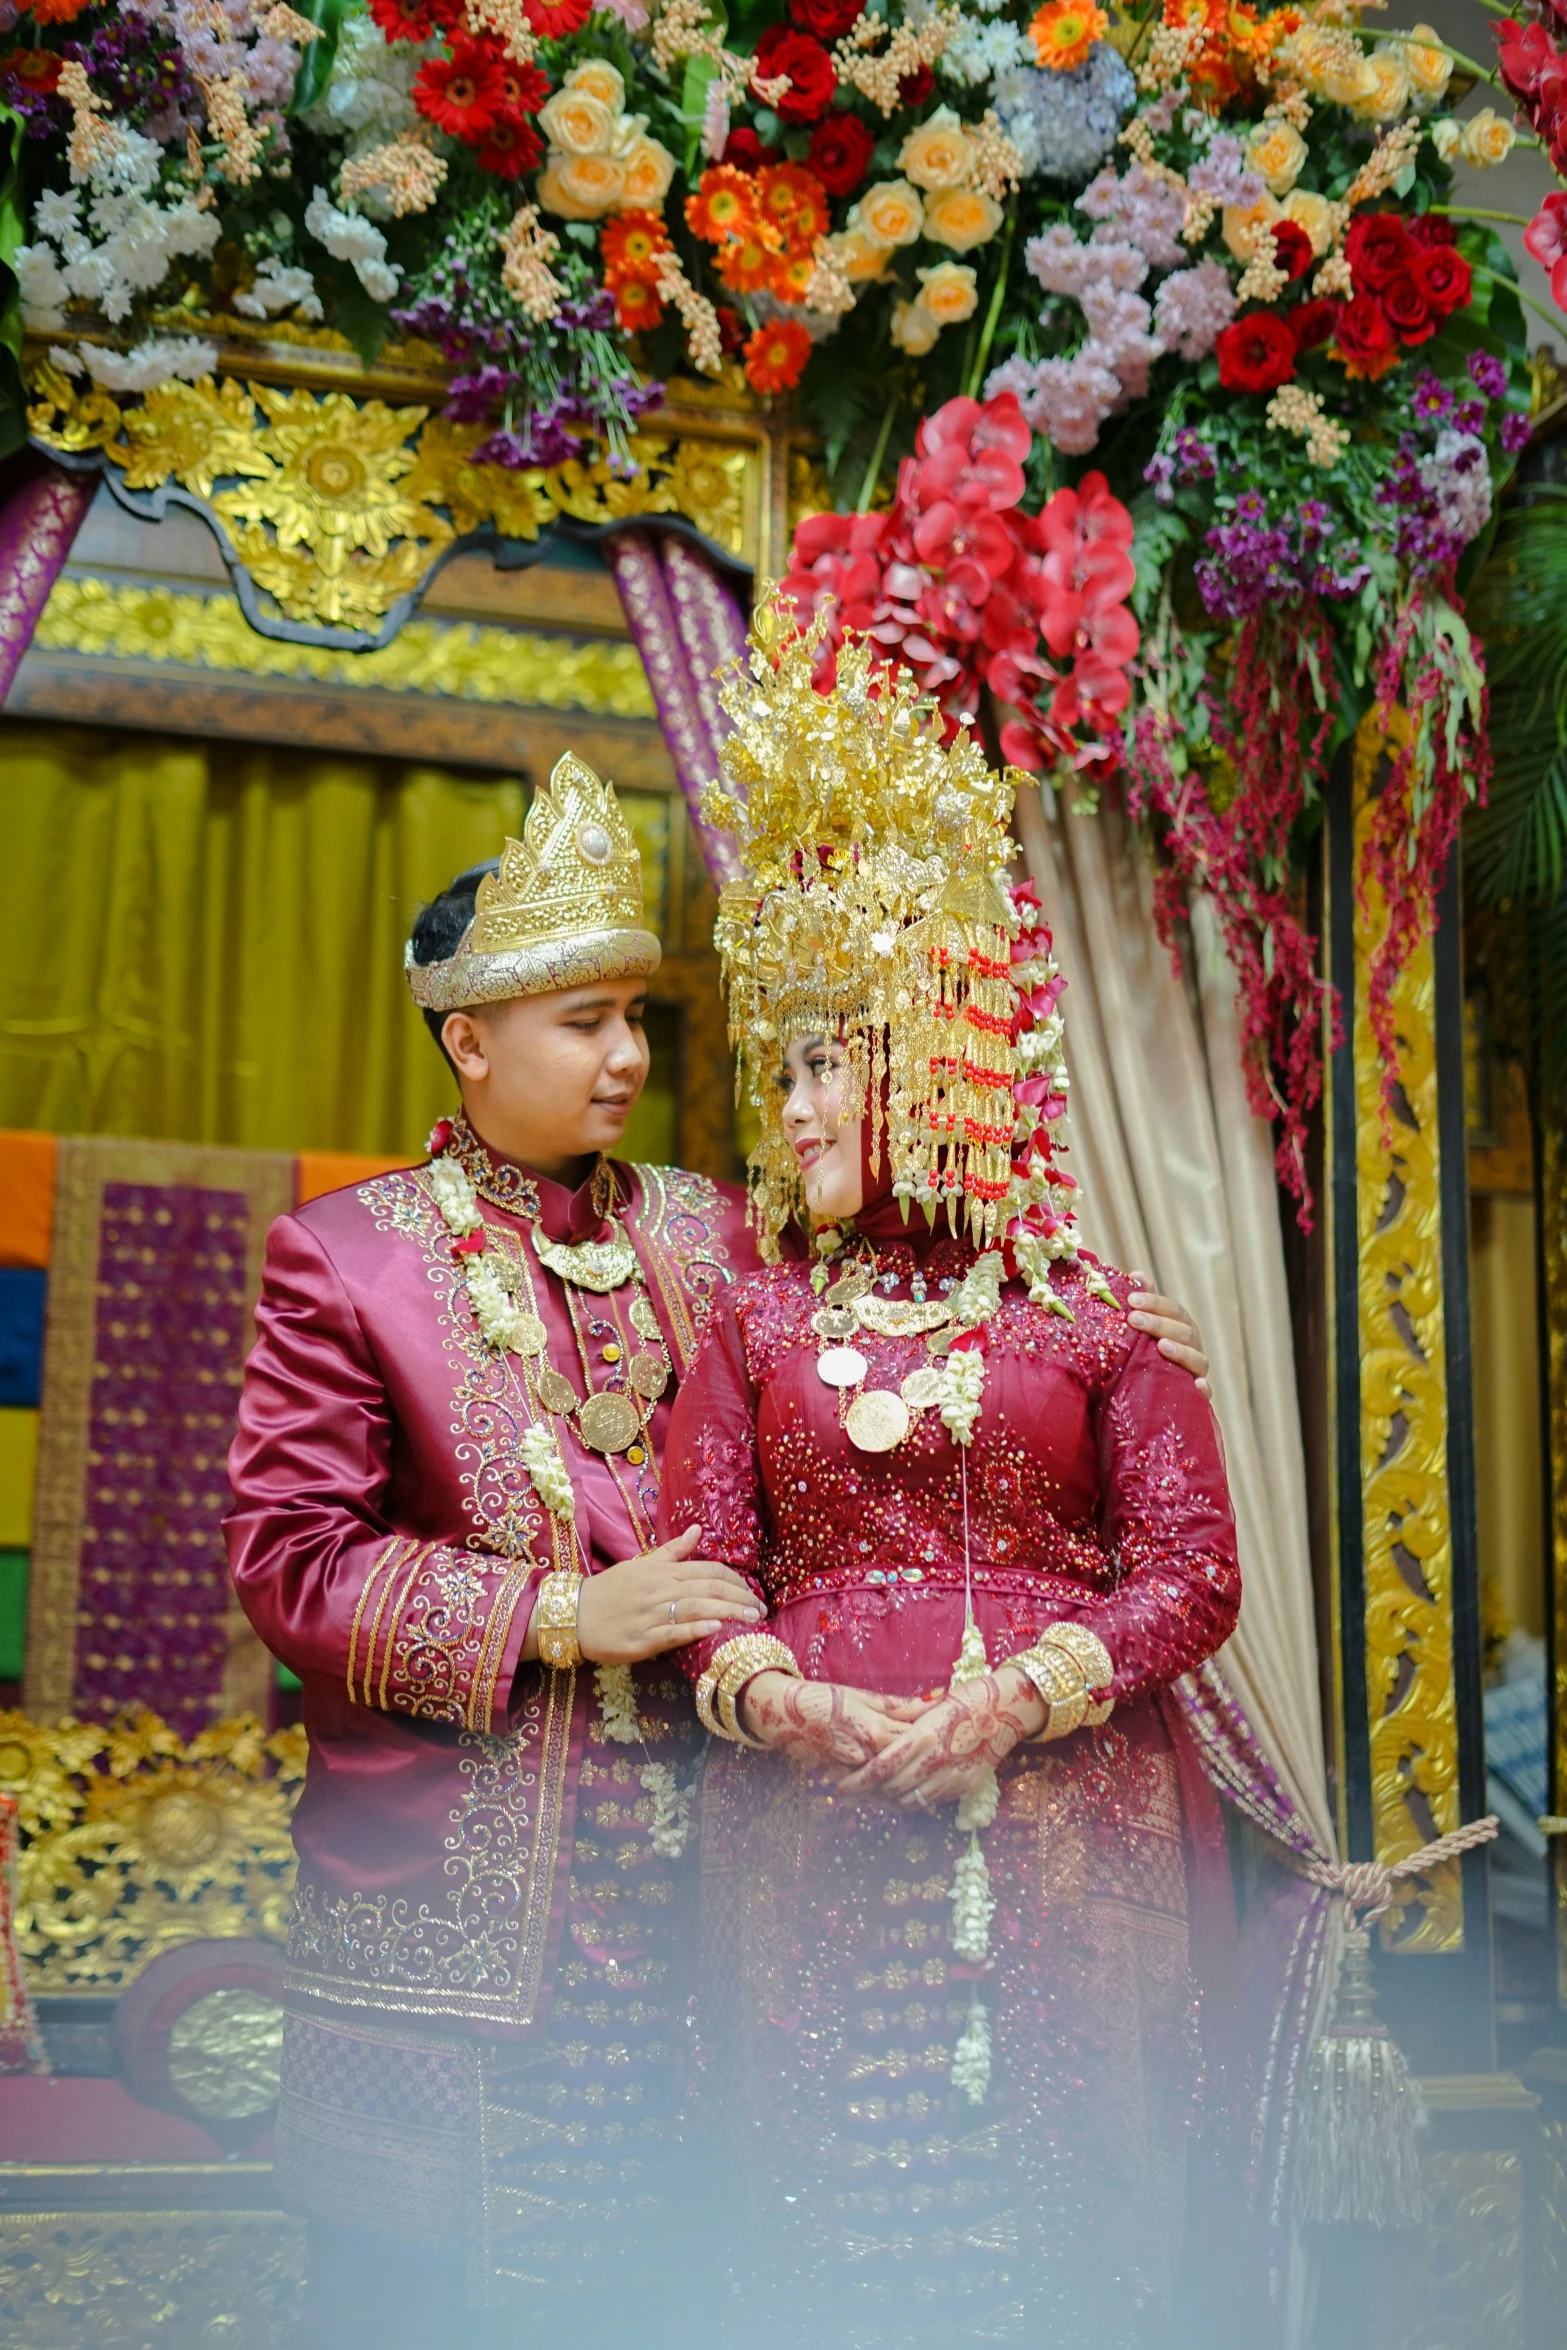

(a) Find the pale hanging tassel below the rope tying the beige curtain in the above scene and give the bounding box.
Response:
[1294,1925,1426,2228]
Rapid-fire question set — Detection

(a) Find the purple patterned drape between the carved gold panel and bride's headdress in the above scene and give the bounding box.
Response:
[606,531,747,886]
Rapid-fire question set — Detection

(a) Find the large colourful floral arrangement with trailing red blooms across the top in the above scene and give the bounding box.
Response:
[0,0,1567,1201]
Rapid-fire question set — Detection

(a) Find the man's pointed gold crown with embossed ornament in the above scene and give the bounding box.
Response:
[404,752,660,1013]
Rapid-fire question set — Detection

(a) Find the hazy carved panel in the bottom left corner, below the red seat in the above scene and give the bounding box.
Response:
[0,2211,305,2350]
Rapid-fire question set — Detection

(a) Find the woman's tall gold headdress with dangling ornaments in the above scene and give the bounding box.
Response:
[705,606,1076,1255]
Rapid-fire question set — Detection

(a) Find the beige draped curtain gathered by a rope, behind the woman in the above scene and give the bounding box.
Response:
[1015,790,1337,1852]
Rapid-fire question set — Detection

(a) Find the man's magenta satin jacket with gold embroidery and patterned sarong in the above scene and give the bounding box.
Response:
[228,1128,754,2308]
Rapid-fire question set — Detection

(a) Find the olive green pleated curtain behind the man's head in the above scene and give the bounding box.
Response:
[0,721,677,1159]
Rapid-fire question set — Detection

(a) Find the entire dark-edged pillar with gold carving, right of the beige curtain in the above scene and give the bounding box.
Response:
[1323,721,1494,2075]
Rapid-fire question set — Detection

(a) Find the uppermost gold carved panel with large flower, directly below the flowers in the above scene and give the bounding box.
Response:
[28,360,761,632]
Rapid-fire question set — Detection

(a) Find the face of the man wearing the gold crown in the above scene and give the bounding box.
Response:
[442,980,648,1175]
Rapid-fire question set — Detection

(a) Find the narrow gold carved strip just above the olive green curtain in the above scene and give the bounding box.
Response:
[35,576,653,719]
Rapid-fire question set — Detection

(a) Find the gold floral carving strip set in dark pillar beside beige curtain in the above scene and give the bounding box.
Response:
[1353,724,1464,1951]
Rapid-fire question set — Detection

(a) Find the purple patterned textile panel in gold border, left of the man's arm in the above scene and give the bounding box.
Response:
[75,1182,251,1739]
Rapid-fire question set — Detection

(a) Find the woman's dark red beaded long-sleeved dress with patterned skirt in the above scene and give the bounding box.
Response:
[665,1210,1240,2350]
